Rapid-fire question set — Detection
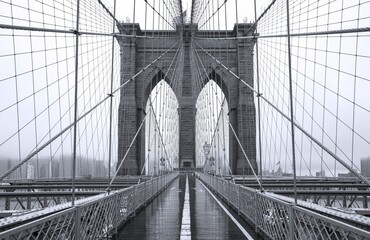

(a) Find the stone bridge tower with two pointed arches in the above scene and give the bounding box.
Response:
[117,23,257,175]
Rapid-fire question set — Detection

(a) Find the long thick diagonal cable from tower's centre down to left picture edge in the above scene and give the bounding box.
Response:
[0,41,180,180]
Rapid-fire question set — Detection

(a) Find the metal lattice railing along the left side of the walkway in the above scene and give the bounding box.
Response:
[0,173,178,239]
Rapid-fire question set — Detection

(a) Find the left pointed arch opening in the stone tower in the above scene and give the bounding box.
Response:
[143,79,179,175]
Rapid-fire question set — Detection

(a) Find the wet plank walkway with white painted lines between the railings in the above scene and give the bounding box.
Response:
[113,174,263,239]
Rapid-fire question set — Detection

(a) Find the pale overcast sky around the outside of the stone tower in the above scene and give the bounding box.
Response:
[0,0,370,178]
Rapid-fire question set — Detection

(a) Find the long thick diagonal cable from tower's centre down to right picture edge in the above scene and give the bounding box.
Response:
[194,38,370,187]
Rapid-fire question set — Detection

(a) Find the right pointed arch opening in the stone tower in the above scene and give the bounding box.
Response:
[195,79,230,175]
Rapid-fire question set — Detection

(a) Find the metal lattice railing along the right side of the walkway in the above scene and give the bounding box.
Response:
[197,173,370,239]
